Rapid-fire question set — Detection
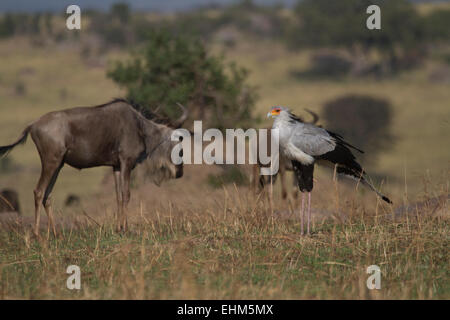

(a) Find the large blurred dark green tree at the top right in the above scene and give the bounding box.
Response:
[289,0,425,73]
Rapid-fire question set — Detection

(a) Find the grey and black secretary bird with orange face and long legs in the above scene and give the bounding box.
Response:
[267,106,392,235]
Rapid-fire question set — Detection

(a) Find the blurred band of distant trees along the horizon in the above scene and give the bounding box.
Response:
[0,0,450,78]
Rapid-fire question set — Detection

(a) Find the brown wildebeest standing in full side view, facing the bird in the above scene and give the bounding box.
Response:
[0,99,187,235]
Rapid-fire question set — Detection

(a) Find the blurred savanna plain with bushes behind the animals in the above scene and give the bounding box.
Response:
[0,0,450,204]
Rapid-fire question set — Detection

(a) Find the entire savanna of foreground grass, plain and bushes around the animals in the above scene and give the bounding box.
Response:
[0,0,450,299]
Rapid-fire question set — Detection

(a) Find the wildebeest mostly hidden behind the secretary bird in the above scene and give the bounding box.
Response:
[252,109,319,199]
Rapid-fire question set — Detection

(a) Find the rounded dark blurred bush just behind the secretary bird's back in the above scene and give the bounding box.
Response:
[323,95,393,161]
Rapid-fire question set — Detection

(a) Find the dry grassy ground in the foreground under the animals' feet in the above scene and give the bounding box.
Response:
[0,186,450,299]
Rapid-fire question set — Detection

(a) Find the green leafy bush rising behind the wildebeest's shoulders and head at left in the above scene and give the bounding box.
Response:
[108,31,256,129]
